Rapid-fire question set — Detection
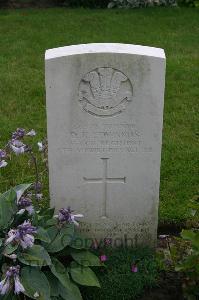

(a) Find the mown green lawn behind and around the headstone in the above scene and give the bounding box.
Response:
[0,8,199,223]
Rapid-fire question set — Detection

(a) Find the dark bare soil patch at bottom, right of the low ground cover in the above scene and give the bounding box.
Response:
[139,272,184,300]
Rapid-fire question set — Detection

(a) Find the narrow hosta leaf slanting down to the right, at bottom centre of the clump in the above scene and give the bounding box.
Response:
[50,257,71,289]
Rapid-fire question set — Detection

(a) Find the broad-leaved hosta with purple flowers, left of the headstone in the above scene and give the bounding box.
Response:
[0,129,103,300]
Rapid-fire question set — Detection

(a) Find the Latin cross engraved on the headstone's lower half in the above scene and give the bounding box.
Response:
[83,158,126,218]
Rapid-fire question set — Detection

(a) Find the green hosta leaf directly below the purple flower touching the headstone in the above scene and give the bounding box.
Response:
[44,225,74,253]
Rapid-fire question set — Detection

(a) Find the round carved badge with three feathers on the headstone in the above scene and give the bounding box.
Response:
[79,67,133,117]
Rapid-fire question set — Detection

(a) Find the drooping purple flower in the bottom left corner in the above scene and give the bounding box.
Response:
[0,266,25,295]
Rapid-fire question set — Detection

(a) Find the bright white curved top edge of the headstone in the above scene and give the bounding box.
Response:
[45,43,165,60]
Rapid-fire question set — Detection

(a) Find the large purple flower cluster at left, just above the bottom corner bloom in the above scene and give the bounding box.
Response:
[5,220,37,249]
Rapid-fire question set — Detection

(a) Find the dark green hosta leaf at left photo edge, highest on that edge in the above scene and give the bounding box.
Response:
[0,189,17,229]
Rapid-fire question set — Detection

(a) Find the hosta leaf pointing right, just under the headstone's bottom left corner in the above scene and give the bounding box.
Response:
[71,250,102,267]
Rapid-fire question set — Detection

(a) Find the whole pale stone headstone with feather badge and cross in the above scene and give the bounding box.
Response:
[45,44,165,245]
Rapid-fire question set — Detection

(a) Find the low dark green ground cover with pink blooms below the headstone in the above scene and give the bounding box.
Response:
[82,248,158,300]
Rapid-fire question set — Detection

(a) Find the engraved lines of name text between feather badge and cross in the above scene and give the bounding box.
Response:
[62,123,152,153]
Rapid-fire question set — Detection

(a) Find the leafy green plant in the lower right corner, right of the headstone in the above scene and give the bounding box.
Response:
[157,196,199,300]
